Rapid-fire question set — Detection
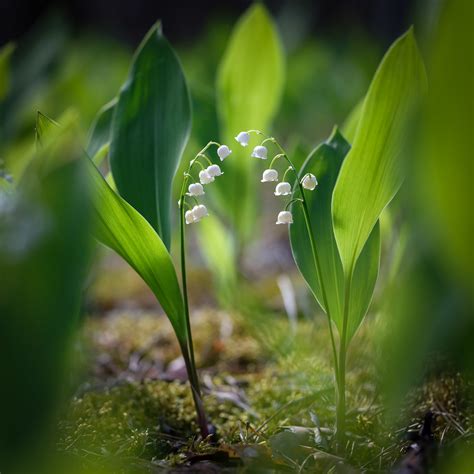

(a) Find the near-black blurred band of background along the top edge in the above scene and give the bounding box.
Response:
[0,0,420,45]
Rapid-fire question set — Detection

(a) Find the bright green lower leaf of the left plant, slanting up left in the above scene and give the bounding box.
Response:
[85,159,187,343]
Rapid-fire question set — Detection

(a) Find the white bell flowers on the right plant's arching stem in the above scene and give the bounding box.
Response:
[235,130,318,224]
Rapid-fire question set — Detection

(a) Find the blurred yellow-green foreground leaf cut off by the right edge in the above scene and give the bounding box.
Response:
[414,0,474,288]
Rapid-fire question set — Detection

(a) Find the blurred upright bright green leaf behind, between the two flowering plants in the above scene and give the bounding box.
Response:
[216,3,284,243]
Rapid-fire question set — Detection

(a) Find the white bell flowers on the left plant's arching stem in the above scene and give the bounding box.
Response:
[179,142,232,224]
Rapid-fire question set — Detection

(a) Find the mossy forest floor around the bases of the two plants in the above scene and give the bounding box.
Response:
[58,258,472,472]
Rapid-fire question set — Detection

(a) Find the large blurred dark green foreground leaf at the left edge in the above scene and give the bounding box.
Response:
[0,126,92,472]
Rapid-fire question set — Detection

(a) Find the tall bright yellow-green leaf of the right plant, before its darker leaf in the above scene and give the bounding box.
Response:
[332,29,426,275]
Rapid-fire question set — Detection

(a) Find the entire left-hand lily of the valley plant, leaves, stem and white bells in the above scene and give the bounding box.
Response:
[86,23,232,438]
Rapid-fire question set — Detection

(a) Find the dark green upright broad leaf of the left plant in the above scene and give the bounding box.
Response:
[110,23,191,248]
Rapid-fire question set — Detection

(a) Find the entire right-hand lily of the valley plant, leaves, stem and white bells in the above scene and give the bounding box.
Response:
[231,29,426,448]
